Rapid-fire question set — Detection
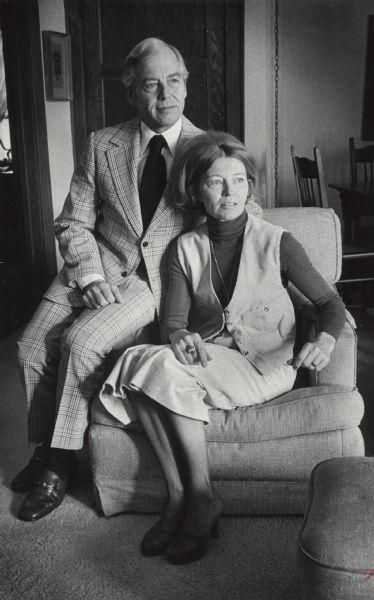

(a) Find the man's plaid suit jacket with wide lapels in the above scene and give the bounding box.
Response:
[44,117,201,314]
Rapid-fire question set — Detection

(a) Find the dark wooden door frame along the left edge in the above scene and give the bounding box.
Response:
[0,0,56,318]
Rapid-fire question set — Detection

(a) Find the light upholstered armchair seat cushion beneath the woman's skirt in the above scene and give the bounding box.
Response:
[91,385,363,443]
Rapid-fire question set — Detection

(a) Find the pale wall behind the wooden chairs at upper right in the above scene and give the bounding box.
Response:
[245,0,374,209]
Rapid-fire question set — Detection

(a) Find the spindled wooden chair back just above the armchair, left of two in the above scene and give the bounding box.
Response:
[291,145,328,208]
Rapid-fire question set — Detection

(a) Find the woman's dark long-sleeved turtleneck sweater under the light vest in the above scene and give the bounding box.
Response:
[161,213,345,343]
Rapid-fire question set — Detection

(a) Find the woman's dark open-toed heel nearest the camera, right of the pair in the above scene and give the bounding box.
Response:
[166,513,221,565]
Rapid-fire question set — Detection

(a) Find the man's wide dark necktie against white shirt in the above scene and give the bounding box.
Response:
[139,135,166,230]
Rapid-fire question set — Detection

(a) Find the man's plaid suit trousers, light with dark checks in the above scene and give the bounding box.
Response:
[18,275,157,450]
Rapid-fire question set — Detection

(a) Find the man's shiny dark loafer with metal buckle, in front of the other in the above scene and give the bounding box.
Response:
[17,469,68,521]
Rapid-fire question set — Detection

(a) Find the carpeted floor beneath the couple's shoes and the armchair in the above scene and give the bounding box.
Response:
[0,313,374,600]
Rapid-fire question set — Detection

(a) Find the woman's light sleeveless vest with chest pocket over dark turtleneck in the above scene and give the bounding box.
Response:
[177,216,295,374]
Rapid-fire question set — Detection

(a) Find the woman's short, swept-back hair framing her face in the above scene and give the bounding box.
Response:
[171,131,256,209]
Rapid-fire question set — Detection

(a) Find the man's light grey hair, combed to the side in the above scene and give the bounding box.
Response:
[122,38,188,94]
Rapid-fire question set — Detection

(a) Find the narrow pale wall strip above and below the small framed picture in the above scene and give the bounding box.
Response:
[39,0,74,268]
